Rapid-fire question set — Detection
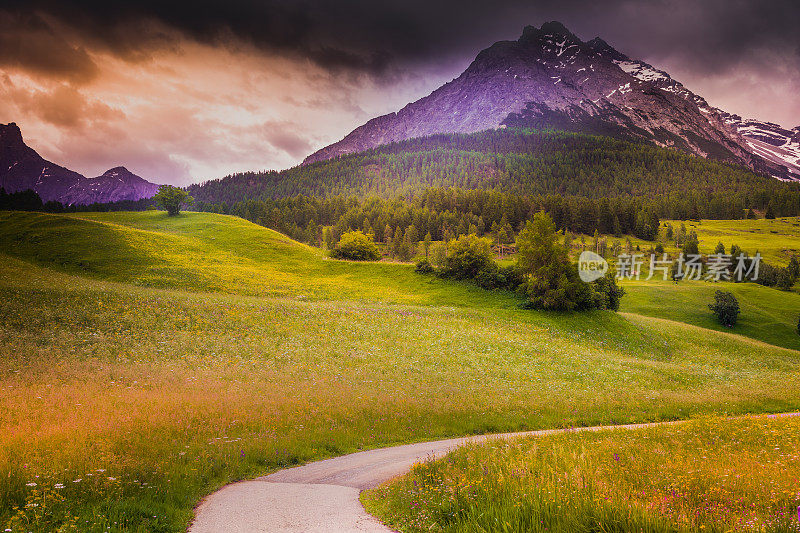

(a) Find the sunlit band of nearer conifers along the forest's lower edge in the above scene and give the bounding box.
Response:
[196,188,660,245]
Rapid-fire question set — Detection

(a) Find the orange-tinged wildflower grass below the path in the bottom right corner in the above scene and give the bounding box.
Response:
[362,417,800,533]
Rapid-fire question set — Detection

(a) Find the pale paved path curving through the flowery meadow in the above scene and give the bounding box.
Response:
[189,413,800,533]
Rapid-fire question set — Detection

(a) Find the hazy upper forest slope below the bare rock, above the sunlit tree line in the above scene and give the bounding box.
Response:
[188,128,800,219]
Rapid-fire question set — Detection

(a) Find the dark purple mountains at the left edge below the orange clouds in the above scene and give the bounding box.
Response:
[0,122,158,205]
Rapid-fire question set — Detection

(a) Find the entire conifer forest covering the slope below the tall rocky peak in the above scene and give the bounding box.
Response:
[188,129,800,243]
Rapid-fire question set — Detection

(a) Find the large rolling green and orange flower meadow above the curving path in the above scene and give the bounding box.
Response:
[0,212,800,532]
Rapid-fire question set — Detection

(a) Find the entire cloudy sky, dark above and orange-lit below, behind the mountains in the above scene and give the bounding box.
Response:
[0,0,800,185]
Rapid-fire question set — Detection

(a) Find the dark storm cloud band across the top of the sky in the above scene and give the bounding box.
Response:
[0,0,800,81]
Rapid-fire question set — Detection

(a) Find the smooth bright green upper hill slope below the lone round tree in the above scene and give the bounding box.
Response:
[0,211,519,306]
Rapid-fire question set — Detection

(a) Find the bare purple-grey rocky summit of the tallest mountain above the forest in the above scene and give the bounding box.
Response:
[304,22,785,179]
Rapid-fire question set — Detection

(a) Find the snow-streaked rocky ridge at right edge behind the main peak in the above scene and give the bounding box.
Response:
[720,111,800,180]
